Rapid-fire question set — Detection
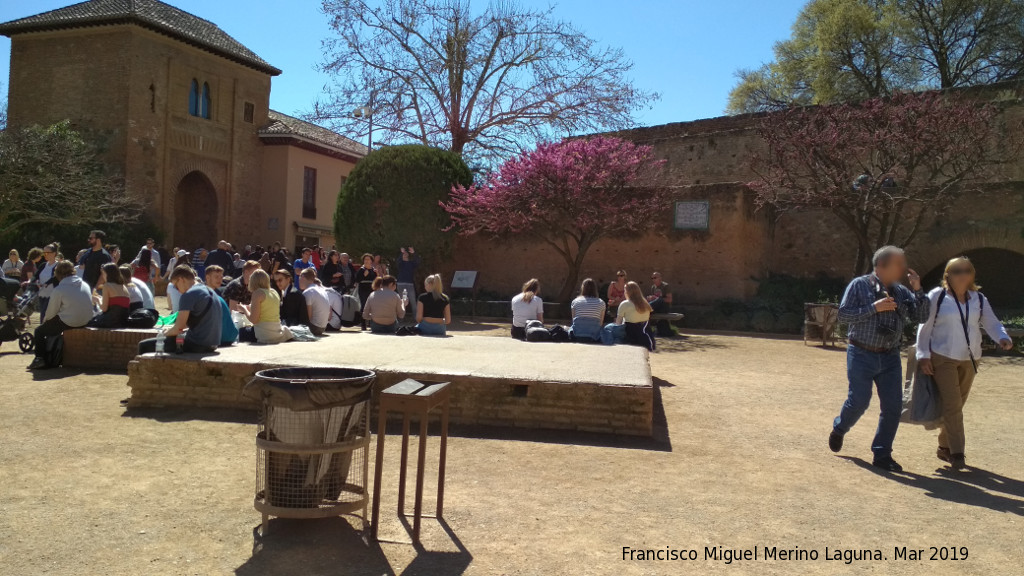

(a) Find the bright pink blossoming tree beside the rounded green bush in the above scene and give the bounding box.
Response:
[442,136,672,302]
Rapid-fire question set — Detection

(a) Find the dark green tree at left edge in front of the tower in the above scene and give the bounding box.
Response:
[0,121,144,235]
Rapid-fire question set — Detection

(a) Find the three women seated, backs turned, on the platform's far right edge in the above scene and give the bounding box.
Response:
[512,278,655,351]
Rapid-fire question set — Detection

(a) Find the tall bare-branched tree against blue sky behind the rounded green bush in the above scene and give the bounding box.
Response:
[311,0,656,161]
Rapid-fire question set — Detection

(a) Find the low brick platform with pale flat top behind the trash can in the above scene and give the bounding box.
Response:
[128,332,653,436]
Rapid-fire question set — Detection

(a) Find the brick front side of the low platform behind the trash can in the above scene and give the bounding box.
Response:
[128,355,654,436]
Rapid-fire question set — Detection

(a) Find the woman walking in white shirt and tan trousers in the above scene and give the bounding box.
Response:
[918,256,1014,469]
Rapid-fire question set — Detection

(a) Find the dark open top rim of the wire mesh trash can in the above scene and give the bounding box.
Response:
[242,368,377,412]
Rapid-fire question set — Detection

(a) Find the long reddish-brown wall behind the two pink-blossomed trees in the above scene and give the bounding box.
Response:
[450,83,1024,304]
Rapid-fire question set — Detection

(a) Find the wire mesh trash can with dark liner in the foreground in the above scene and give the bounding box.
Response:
[243,368,377,534]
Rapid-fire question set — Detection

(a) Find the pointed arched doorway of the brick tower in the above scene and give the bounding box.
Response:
[174,171,218,251]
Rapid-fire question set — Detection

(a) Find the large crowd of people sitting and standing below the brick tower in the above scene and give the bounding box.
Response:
[3,230,452,369]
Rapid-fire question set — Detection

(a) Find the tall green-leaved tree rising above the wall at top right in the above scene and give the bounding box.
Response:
[726,0,1024,114]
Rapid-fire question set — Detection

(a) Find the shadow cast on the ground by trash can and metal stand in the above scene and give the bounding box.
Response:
[234,518,473,576]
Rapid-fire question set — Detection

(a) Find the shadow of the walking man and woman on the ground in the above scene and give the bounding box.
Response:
[840,456,1024,516]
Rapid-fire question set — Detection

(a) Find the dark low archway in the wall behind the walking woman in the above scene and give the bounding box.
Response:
[923,248,1024,312]
